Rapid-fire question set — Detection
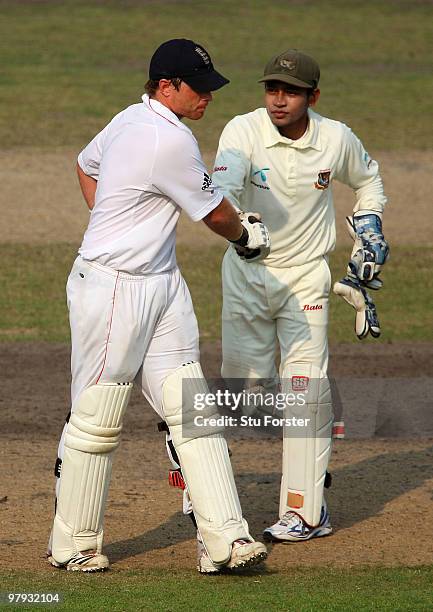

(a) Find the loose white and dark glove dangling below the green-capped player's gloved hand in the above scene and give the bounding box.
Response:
[334,276,380,340]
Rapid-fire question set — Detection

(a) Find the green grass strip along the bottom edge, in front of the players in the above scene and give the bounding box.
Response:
[0,567,433,612]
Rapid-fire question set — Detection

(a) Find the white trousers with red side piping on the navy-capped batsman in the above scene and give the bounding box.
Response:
[58,257,199,459]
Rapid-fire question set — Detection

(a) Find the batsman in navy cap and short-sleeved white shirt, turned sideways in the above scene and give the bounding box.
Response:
[48,39,269,572]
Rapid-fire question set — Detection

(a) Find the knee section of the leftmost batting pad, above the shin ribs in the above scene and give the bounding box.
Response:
[65,383,132,453]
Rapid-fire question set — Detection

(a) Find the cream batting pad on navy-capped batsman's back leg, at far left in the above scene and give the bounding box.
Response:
[52,383,132,563]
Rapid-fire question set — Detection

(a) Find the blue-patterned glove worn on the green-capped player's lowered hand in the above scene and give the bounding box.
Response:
[346,211,389,289]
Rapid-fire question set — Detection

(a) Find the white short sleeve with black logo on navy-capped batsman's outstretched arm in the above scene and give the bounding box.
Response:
[152,130,223,221]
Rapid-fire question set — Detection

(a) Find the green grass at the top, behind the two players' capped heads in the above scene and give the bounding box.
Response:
[0,0,433,150]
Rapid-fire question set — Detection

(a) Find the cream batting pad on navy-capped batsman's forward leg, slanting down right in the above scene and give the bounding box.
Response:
[163,362,250,564]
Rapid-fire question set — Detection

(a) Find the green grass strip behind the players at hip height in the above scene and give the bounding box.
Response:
[0,246,433,342]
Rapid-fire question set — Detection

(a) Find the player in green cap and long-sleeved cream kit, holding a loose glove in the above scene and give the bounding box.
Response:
[213,49,388,542]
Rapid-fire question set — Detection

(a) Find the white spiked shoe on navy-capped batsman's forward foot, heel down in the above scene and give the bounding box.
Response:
[197,540,268,574]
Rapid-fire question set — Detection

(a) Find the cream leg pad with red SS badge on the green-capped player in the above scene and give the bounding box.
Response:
[280,363,333,527]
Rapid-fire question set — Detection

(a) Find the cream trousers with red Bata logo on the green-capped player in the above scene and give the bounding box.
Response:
[222,248,331,379]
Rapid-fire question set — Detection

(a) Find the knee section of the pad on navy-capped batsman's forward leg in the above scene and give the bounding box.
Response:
[162,361,223,446]
